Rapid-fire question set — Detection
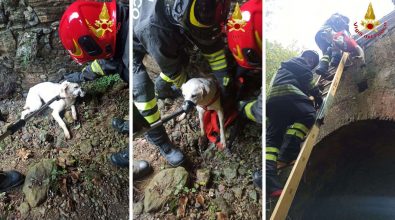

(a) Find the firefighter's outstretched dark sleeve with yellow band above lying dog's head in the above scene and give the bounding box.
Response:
[64,59,119,83]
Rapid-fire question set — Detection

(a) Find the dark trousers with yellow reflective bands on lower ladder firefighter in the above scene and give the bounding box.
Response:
[266,96,316,193]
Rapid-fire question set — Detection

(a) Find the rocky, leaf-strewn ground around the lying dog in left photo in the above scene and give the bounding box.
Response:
[0,77,129,219]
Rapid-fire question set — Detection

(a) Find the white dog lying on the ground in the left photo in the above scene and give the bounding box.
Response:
[21,81,85,139]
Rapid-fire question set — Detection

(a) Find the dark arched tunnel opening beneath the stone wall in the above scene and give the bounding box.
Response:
[287,120,395,220]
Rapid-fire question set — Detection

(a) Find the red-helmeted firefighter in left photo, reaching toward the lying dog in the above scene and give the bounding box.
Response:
[59,0,129,167]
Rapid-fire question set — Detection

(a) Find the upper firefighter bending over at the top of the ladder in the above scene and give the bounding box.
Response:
[315,13,351,76]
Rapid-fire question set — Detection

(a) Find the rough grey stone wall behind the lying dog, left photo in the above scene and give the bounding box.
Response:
[0,0,79,99]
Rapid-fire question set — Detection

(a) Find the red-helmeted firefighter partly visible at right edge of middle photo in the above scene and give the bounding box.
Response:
[227,0,262,188]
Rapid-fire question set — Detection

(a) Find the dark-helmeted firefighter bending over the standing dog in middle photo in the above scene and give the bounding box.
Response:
[132,0,230,166]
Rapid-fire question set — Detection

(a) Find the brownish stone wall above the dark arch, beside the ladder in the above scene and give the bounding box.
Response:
[317,13,395,143]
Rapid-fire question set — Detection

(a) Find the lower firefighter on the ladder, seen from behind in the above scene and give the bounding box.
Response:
[266,50,322,197]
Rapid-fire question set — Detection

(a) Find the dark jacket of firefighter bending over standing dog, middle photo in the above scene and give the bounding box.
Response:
[132,0,227,87]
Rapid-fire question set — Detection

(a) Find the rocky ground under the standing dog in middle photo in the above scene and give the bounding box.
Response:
[133,98,262,219]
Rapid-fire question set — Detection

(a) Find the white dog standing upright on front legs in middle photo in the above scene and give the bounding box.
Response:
[181,78,226,148]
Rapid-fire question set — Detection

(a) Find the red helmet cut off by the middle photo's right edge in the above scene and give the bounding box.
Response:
[226,0,262,69]
